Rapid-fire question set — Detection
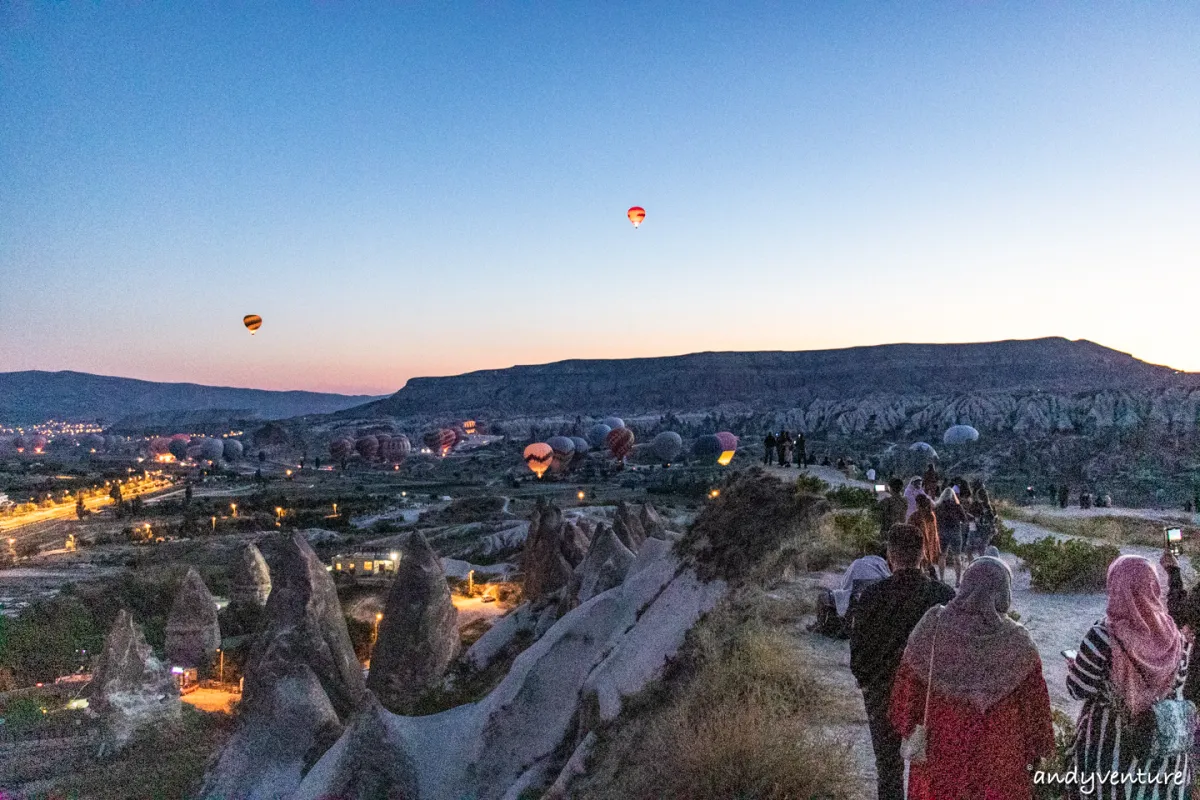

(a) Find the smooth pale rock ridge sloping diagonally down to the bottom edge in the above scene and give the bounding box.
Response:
[296,542,725,800]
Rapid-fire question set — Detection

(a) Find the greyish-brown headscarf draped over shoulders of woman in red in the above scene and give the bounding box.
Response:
[904,557,1042,712]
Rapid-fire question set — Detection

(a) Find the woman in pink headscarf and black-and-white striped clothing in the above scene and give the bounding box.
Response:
[1067,555,1192,800]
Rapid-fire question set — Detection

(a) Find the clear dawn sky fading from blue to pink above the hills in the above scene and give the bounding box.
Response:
[0,0,1200,393]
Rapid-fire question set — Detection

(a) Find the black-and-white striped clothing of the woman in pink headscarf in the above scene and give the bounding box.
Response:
[1067,621,1192,800]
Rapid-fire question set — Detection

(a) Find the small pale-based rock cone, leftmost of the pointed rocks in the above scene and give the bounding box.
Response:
[88,610,180,750]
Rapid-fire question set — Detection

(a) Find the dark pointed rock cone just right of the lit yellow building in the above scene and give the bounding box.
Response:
[367,531,458,712]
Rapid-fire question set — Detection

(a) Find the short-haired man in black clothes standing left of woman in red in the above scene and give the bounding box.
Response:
[850,525,954,800]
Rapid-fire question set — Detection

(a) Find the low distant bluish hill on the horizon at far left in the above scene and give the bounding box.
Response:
[0,371,384,423]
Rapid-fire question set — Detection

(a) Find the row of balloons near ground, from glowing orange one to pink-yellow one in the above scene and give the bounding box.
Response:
[524,416,738,477]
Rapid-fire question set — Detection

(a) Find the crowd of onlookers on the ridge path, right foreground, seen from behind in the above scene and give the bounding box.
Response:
[818,474,1200,800]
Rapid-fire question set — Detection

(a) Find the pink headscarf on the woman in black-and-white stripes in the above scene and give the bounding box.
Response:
[1105,555,1183,714]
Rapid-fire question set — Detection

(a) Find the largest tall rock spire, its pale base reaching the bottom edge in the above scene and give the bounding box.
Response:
[203,534,370,800]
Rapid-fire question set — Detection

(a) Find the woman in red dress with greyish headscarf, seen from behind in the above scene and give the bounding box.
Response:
[890,557,1054,800]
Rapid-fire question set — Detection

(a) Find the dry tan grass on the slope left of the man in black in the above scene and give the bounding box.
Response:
[572,592,854,800]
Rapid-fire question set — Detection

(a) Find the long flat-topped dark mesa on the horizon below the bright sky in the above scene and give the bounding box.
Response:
[342,338,1198,417]
